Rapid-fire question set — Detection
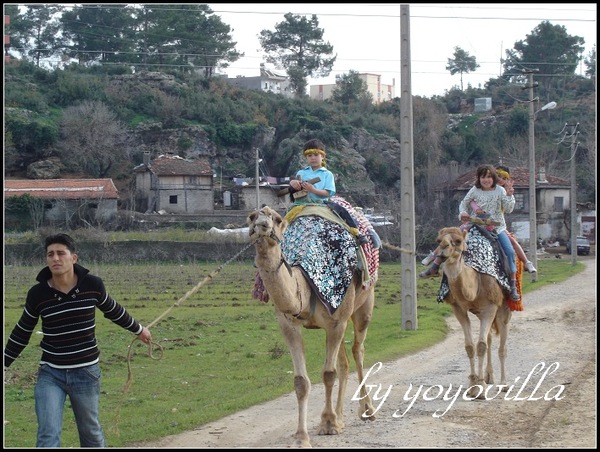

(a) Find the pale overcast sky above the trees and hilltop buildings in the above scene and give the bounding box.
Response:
[209,3,596,97]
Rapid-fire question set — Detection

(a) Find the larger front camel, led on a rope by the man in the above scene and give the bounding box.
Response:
[247,207,375,447]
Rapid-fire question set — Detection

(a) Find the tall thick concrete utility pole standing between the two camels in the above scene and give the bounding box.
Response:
[400,4,417,330]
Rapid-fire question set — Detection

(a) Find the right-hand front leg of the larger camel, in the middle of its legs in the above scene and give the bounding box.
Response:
[319,321,348,435]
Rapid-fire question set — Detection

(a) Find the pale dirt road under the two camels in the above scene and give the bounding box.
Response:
[136,258,597,449]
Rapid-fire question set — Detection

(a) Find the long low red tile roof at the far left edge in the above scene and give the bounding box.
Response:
[4,179,119,199]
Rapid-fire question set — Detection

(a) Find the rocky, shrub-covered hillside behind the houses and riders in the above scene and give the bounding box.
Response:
[5,63,596,237]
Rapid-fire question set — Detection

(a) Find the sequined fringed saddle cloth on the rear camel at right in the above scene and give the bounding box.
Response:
[437,225,523,311]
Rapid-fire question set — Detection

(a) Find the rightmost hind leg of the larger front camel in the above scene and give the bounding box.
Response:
[352,290,375,421]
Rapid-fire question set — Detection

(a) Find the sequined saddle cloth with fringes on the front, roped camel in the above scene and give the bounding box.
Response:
[253,197,379,314]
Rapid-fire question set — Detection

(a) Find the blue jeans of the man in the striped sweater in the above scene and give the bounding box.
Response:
[34,364,105,447]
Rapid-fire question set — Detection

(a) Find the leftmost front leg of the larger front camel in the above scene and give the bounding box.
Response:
[276,311,311,447]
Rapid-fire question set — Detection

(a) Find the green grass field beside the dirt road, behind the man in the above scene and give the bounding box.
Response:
[4,259,583,448]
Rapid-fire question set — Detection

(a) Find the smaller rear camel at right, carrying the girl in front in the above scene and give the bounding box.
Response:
[437,227,512,397]
